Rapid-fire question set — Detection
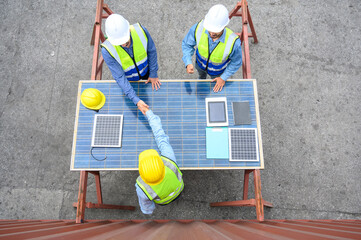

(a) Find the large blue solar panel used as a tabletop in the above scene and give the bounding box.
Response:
[70,80,263,170]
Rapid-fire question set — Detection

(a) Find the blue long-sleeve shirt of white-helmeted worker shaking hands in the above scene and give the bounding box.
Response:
[101,26,158,105]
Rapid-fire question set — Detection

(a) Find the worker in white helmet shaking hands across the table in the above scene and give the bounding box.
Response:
[101,14,161,113]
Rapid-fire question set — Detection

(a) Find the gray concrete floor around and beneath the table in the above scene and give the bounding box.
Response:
[0,0,361,219]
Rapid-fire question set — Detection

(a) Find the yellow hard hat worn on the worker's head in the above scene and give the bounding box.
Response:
[139,149,165,185]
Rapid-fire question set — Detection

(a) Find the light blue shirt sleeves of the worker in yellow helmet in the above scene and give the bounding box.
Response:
[135,110,177,214]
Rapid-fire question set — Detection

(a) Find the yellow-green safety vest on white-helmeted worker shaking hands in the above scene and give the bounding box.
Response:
[101,23,148,81]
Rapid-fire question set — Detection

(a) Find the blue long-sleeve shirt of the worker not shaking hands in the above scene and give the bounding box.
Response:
[182,23,242,81]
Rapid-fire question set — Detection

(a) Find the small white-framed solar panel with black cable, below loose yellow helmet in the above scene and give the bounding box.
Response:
[92,114,123,147]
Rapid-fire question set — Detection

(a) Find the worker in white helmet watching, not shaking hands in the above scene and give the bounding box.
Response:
[182,4,242,92]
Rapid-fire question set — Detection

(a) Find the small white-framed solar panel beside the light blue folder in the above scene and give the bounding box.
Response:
[228,128,259,162]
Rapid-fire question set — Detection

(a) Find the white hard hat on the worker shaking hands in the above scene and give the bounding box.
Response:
[105,13,130,45]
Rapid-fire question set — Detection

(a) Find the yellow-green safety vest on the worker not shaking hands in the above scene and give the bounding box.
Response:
[195,20,238,76]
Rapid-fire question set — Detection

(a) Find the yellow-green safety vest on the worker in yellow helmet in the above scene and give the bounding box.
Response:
[137,156,184,205]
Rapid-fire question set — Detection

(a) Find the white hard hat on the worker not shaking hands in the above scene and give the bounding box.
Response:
[203,4,229,33]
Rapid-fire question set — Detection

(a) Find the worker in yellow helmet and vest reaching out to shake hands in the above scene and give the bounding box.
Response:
[135,109,184,214]
